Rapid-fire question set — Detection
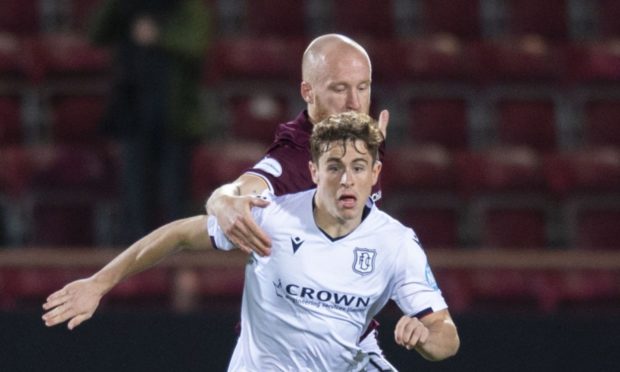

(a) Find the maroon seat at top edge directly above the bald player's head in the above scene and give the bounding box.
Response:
[330,0,396,39]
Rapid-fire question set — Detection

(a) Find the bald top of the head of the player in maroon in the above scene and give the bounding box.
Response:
[301,34,370,83]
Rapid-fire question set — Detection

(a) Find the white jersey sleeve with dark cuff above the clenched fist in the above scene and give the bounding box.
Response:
[392,229,448,316]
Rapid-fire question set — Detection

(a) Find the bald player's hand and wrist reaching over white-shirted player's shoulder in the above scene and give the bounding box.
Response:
[205,173,271,256]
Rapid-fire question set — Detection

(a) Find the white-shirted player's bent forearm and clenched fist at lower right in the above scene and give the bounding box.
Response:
[394,309,460,361]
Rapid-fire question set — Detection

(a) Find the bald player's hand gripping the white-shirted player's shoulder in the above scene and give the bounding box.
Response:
[213,196,271,256]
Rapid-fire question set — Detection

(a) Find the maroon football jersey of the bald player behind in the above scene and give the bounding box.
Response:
[246,111,385,201]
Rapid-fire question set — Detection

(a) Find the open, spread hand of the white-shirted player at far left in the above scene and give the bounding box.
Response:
[42,278,105,330]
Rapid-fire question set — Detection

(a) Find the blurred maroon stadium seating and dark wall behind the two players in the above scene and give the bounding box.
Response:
[0,0,620,371]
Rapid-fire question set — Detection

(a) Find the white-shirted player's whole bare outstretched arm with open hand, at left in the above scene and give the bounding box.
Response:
[43,215,212,329]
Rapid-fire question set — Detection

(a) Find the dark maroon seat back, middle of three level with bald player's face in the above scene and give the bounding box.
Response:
[495,97,558,152]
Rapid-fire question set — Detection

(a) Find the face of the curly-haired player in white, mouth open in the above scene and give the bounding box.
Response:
[310,140,381,224]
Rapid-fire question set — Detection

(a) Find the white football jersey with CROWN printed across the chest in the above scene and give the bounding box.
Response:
[208,190,447,372]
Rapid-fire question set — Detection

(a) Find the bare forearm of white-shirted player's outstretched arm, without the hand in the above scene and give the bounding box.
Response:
[94,216,211,292]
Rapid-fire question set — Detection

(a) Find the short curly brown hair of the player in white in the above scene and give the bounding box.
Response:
[310,111,383,163]
